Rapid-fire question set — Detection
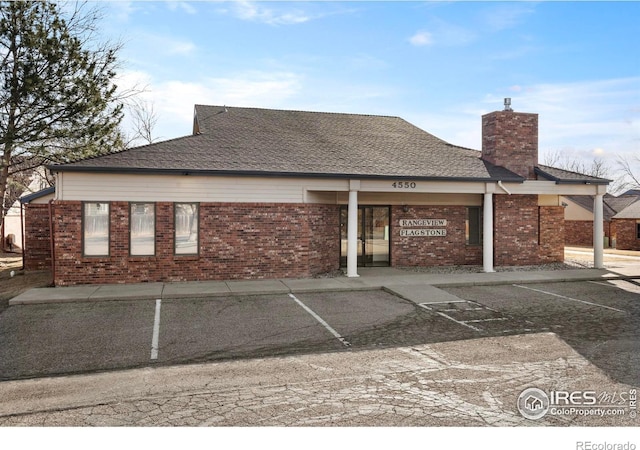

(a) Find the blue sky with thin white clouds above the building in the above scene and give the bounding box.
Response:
[101,1,640,186]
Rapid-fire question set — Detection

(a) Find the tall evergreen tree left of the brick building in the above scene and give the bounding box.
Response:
[0,0,123,219]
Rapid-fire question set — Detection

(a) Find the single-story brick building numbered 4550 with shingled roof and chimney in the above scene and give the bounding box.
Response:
[20,101,609,285]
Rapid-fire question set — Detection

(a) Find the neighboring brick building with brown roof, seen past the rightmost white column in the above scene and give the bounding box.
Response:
[561,193,640,248]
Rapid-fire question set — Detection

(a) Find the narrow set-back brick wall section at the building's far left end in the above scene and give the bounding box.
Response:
[24,203,51,270]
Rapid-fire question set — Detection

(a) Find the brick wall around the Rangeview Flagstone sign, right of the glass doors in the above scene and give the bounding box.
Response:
[391,206,482,267]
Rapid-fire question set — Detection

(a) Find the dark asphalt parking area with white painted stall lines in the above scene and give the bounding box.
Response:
[0,280,640,386]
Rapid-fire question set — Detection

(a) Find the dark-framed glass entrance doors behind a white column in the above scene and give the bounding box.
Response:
[340,206,390,267]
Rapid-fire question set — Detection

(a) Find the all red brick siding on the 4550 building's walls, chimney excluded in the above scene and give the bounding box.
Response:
[32,195,564,285]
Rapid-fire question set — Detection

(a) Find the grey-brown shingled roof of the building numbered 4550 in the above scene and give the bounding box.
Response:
[50,105,606,182]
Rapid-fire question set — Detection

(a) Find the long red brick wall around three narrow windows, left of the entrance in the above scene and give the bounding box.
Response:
[54,202,339,285]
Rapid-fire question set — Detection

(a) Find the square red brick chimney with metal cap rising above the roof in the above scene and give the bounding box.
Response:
[482,98,538,180]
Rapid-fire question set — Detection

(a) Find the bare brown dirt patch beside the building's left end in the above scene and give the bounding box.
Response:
[0,253,51,313]
